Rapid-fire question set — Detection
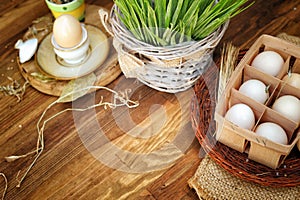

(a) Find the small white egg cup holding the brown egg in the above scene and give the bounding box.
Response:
[51,24,90,65]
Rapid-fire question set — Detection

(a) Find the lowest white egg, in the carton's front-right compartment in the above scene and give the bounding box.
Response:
[255,122,288,144]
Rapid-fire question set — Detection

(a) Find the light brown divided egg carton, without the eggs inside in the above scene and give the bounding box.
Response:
[215,35,300,169]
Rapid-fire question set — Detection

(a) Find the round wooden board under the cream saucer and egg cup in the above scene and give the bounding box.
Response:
[19,5,121,96]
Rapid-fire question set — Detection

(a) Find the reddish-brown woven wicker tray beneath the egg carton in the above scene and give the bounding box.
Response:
[191,51,300,187]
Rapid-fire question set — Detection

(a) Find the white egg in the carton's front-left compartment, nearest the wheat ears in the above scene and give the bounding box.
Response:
[225,103,255,130]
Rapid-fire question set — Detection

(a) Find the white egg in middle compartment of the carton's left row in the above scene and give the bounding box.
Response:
[239,79,269,104]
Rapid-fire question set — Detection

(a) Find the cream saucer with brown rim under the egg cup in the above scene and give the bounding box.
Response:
[35,24,111,80]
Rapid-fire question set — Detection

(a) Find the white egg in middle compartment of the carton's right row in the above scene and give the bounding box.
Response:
[272,95,300,123]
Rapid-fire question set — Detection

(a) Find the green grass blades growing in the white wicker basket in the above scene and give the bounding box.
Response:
[114,0,254,46]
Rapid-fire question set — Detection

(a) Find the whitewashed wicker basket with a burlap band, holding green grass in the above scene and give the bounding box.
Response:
[99,5,229,93]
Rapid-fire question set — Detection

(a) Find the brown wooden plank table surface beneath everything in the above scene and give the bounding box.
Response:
[0,0,300,199]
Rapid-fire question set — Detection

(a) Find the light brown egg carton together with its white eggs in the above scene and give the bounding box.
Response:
[215,35,300,169]
